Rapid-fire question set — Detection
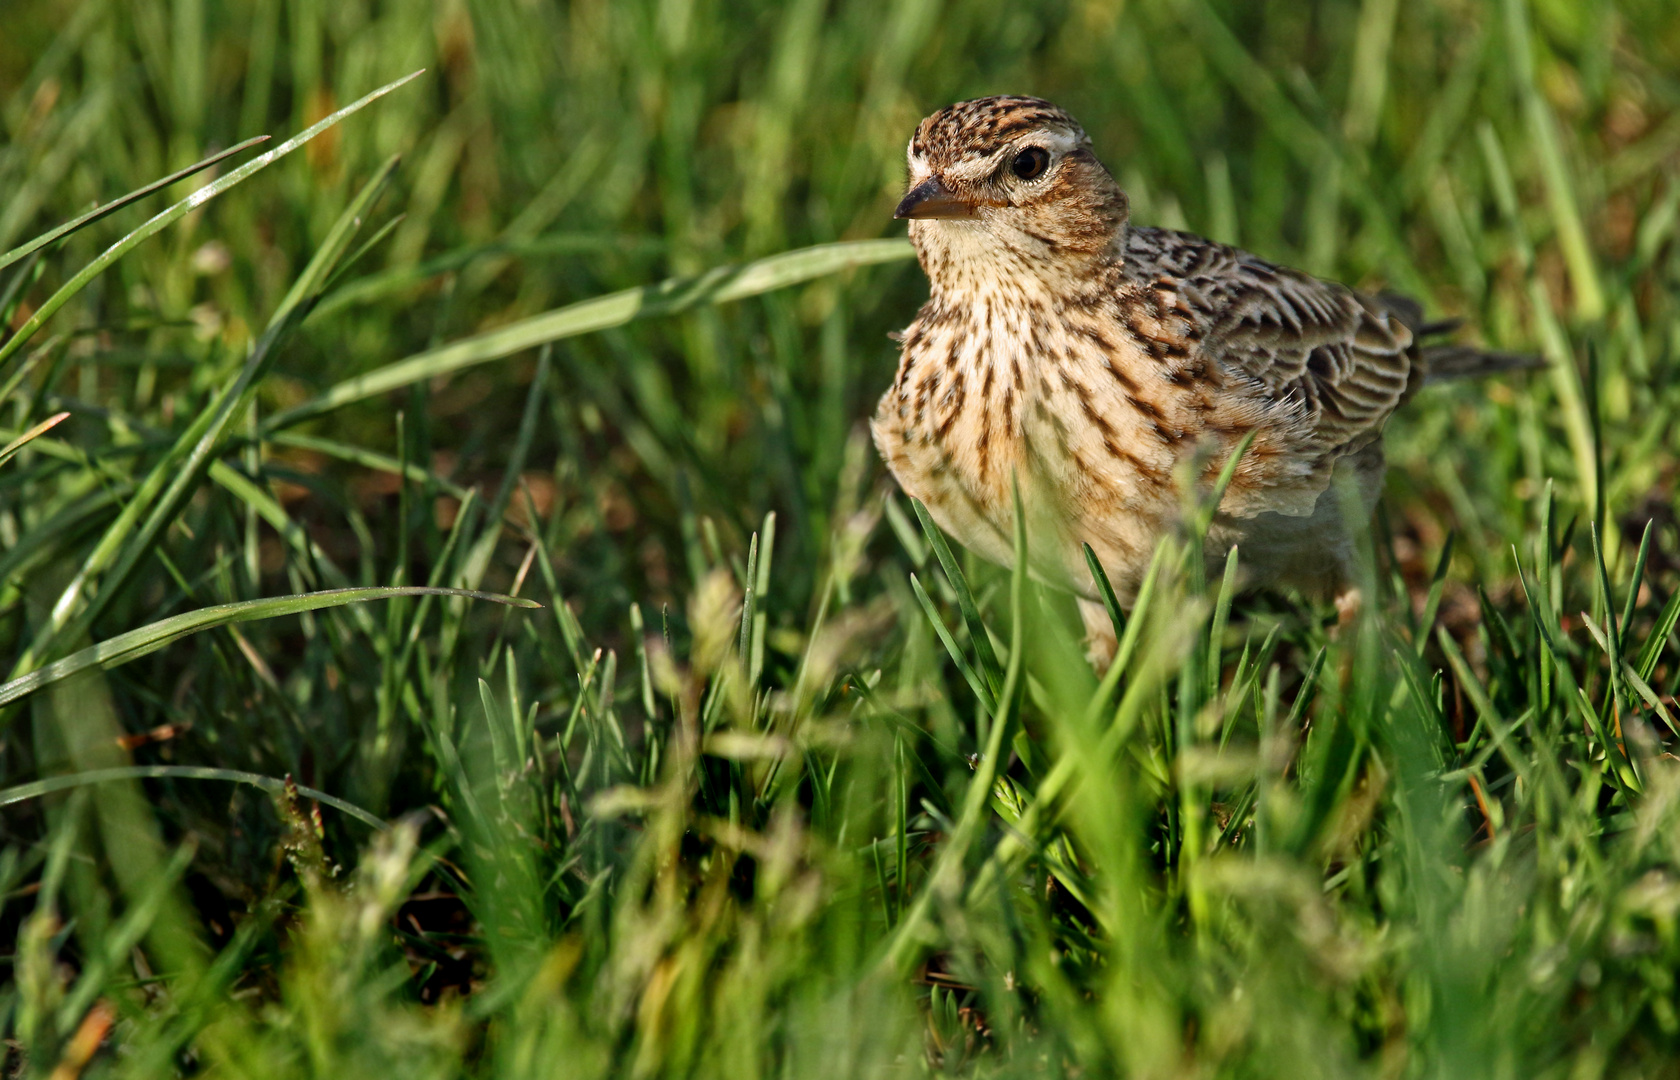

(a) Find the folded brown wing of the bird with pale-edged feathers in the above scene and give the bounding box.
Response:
[1127,228,1418,514]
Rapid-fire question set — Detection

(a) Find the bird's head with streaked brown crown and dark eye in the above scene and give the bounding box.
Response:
[894,97,1127,286]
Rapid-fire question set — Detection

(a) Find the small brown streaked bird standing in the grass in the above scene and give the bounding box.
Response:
[870,96,1529,662]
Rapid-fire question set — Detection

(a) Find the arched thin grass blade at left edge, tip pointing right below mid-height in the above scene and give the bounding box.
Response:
[0,586,530,705]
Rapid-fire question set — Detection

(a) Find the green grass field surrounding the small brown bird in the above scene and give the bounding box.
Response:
[0,0,1680,1080]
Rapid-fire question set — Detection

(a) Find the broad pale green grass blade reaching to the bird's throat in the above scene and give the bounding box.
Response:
[264,240,914,432]
